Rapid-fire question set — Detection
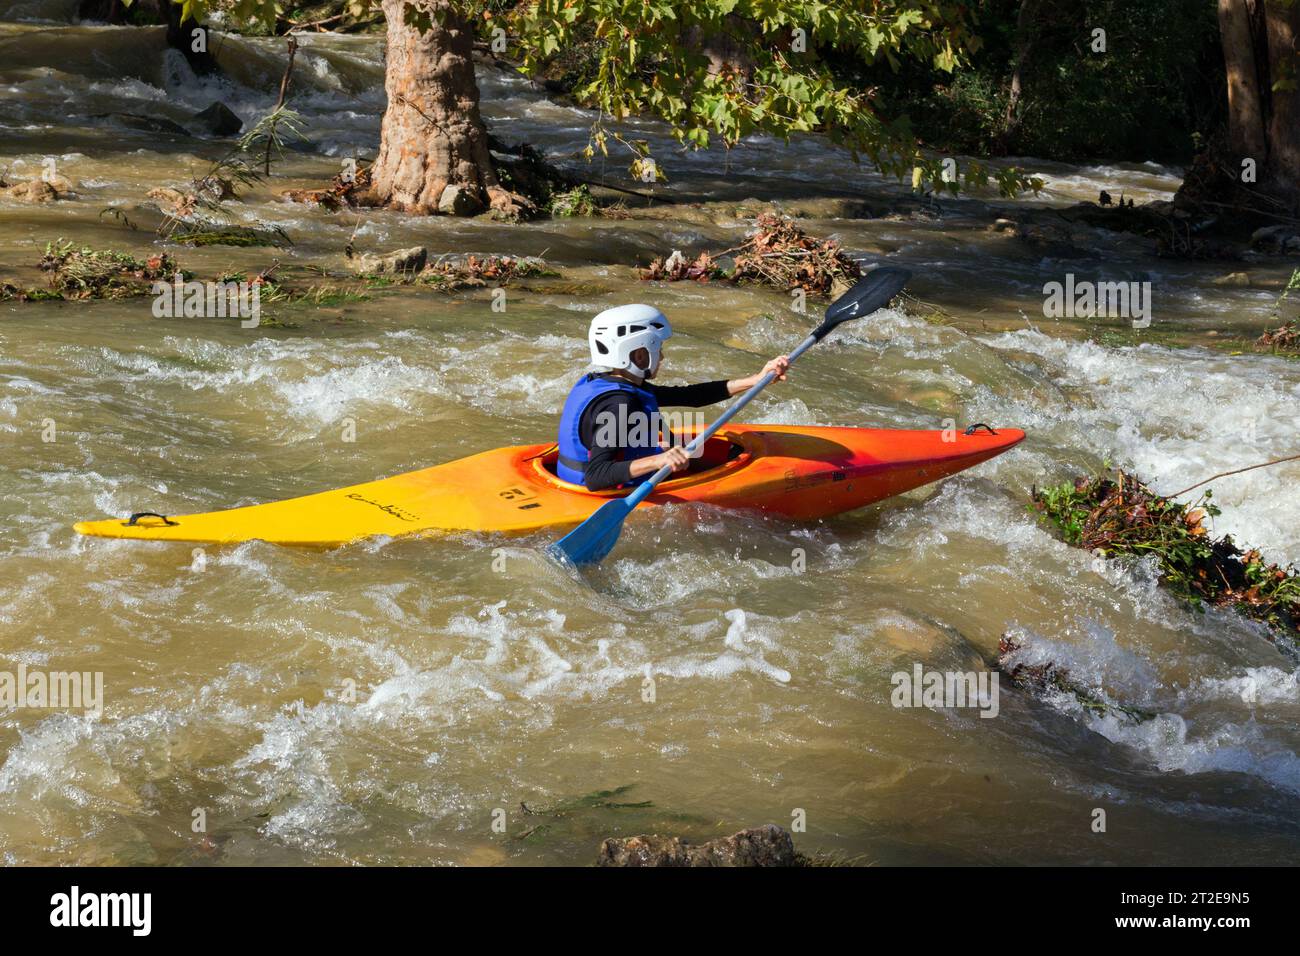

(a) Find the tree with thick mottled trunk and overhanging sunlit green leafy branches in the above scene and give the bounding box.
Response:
[129,0,1040,219]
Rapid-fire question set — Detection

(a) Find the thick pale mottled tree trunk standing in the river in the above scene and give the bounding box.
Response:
[368,0,529,219]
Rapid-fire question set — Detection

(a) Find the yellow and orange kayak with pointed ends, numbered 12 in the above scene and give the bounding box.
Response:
[74,425,1024,548]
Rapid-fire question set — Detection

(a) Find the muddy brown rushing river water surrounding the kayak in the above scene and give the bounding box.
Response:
[0,14,1300,864]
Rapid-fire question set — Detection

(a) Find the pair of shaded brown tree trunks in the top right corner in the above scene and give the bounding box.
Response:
[1218,0,1300,215]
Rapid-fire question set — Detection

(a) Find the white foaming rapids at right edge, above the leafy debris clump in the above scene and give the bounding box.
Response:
[982,329,1300,562]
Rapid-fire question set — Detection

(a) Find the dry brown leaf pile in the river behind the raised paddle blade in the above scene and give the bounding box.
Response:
[641,213,862,295]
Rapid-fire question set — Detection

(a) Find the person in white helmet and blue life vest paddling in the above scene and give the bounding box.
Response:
[555,304,789,492]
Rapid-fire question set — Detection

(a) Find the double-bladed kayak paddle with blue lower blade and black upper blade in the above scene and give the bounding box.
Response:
[547,267,911,564]
